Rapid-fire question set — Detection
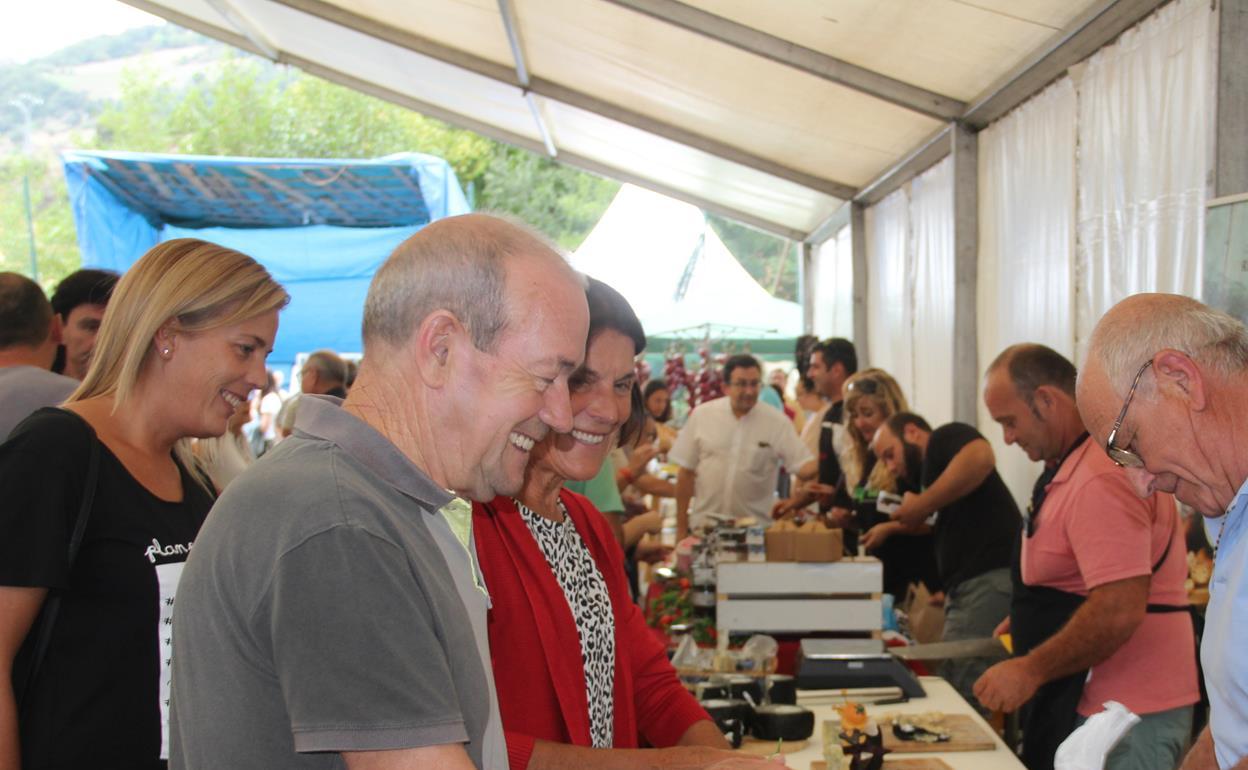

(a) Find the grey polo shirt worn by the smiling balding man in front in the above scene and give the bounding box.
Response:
[170,397,507,770]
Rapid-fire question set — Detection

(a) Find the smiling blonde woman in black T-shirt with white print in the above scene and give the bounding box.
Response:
[0,238,288,770]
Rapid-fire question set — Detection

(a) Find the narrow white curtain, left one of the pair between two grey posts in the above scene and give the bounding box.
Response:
[864,188,915,399]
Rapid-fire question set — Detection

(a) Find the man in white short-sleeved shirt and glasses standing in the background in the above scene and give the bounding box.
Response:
[668,356,815,539]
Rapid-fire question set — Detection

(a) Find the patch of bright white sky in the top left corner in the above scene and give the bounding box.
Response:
[0,0,163,61]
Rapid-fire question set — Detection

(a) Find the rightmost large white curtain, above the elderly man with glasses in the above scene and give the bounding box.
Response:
[1076,0,1217,356]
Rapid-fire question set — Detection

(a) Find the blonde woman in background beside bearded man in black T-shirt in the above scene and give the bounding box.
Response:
[829,369,938,600]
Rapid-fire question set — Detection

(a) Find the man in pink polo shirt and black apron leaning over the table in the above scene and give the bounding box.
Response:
[975,344,1199,770]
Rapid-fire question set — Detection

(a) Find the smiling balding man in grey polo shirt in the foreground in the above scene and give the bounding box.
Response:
[171,215,589,770]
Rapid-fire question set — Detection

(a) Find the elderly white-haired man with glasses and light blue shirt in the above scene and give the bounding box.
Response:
[1077,295,1248,770]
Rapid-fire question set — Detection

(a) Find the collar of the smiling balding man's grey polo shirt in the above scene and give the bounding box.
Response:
[295,394,456,512]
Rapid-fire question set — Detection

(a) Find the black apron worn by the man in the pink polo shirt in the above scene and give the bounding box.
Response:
[1010,433,1188,770]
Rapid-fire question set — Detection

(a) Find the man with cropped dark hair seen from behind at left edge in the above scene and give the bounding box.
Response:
[0,272,79,442]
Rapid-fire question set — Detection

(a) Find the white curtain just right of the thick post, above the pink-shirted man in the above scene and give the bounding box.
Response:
[978,77,1077,504]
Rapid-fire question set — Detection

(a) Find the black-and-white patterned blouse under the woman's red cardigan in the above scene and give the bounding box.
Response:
[515,500,615,749]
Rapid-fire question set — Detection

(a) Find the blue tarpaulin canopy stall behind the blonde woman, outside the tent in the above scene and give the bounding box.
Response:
[61,151,469,367]
